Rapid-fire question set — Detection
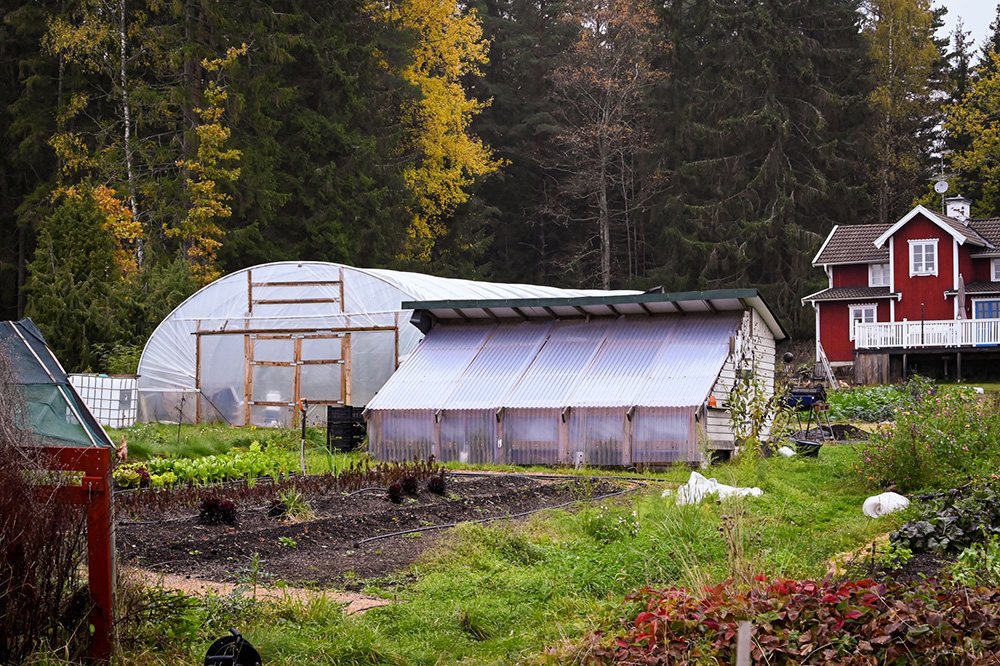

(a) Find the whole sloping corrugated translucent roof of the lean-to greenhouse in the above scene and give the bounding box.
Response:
[368,311,742,411]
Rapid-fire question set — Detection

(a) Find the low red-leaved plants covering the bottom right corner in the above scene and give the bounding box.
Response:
[576,580,1000,666]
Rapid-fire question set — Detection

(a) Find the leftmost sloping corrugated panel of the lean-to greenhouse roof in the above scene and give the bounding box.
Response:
[368,325,495,410]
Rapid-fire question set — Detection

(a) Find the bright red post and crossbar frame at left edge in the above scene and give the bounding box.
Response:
[37,447,114,661]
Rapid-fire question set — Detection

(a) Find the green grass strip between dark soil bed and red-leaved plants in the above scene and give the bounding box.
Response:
[115,446,901,666]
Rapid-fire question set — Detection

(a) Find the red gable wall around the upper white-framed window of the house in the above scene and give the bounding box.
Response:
[890,215,964,321]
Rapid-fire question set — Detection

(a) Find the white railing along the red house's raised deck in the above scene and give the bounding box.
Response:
[854,319,1000,349]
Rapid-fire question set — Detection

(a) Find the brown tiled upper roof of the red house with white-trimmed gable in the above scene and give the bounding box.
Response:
[813,206,1000,266]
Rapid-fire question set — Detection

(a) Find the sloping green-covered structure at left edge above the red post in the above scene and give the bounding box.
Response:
[0,319,113,447]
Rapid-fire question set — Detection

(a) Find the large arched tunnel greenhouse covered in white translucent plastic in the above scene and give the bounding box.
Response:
[138,262,633,426]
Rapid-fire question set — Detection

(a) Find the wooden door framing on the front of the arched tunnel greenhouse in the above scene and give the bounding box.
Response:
[192,326,399,426]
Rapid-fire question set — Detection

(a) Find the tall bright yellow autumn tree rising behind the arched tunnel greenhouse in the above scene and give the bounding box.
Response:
[386,0,502,262]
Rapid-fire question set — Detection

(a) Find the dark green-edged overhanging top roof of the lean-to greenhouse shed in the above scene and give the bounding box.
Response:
[402,289,788,340]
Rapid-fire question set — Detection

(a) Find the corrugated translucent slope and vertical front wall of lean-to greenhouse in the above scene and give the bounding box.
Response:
[367,306,744,465]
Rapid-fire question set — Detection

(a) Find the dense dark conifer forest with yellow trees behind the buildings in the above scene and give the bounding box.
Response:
[0,0,1000,371]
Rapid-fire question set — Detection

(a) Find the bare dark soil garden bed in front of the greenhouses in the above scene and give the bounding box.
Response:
[116,476,624,587]
